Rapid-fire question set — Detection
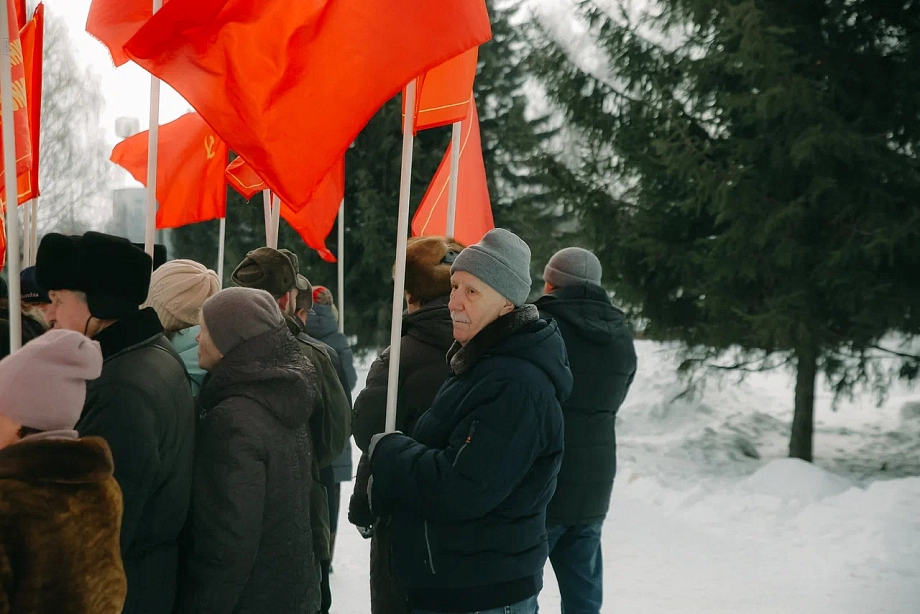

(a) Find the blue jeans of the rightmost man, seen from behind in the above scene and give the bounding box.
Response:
[546,522,604,614]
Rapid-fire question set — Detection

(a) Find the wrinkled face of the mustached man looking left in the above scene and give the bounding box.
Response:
[448,271,514,346]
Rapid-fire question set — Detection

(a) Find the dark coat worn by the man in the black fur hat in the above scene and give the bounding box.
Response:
[76,308,195,614]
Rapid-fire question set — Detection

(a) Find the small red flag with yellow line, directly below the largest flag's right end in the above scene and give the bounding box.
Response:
[403,47,479,134]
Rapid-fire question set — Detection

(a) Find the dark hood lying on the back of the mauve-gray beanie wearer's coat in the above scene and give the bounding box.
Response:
[199,326,316,429]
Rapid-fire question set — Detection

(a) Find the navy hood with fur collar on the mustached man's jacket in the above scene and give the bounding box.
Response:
[447,305,574,402]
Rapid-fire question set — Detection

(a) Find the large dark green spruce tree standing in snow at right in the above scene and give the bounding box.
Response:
[530,0,920,460]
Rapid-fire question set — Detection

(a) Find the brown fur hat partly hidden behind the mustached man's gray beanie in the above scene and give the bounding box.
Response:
[406,237,463,303]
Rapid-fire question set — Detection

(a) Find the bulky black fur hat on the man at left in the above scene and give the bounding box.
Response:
[35,232,153,320]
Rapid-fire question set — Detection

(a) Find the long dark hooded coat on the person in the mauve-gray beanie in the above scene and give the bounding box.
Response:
[181,328,319,614]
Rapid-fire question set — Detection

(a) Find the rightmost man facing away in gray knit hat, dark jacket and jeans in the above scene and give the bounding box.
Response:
[536,247,636,614]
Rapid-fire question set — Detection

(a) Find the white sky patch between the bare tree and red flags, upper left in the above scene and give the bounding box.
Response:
[44,0,190,145]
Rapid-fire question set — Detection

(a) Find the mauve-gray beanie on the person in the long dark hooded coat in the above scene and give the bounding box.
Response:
[201,288,286,356]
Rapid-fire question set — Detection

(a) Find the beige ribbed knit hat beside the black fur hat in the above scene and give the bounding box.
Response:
[144,260,220,332]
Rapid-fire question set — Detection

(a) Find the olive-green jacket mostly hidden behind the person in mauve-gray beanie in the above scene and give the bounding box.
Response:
[287,319,351,561]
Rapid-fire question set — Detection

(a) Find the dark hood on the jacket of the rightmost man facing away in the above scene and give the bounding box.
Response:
[535,285,630,345]
